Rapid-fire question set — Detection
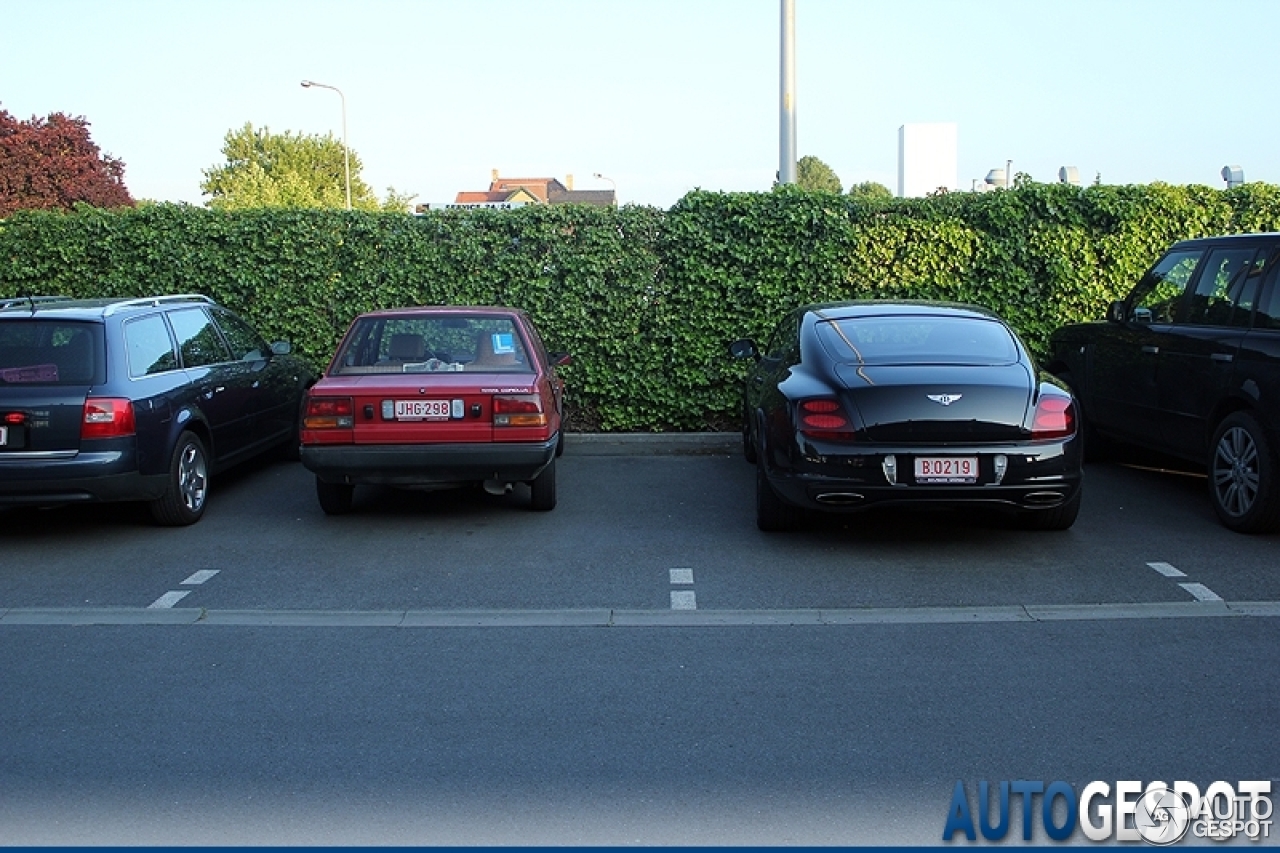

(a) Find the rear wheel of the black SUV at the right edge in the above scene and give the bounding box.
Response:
[1208,411,1280,533]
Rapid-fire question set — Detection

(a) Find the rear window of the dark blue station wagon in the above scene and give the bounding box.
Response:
[0,319,105,386]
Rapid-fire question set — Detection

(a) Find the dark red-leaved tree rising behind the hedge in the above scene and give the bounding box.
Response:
[0,109,133,216]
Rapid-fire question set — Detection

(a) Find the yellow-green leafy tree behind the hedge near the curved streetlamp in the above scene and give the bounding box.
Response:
[200,123,412,210]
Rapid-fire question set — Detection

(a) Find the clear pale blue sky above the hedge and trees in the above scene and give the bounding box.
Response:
[0,0,1280,207]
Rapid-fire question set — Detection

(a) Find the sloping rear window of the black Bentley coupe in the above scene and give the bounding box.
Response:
[817,316,1018,365]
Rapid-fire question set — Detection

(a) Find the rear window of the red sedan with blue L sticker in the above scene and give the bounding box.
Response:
[333,314,534,375]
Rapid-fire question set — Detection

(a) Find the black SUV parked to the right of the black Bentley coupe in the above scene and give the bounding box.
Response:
[1050,233,1280,533]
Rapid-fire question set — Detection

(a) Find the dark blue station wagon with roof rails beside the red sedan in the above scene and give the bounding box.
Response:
[0,296,316,525]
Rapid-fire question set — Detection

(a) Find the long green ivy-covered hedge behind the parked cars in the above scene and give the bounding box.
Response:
[0,183,1280,430]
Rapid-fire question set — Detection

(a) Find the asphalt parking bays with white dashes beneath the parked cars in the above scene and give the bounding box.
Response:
[0,437,1280,624]
